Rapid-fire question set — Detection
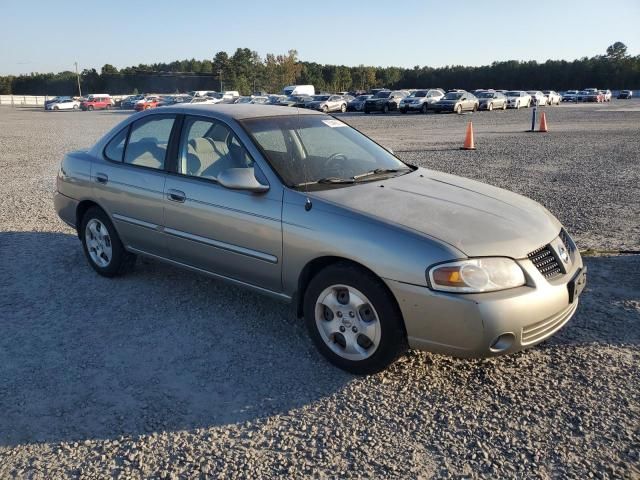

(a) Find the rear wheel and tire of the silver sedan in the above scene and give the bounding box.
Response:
[80,207,136,277]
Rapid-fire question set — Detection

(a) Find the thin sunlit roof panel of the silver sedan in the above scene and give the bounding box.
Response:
[166,103,322,120]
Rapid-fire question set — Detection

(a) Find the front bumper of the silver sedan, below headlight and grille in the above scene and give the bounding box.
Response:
[385,250,586,358]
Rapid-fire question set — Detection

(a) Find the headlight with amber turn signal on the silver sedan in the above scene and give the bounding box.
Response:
[428,257,525,293]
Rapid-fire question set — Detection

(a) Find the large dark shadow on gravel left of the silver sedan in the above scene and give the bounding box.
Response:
[0,230,353,445]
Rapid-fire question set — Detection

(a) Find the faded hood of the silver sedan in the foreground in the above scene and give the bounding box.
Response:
[309,168,561,258]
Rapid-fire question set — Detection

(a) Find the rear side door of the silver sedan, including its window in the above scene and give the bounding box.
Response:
[92,115,175,257]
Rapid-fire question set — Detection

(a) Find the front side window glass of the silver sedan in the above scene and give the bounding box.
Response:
[178,117,253,180]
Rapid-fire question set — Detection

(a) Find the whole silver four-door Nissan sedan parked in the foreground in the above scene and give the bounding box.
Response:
[55,105,586,373]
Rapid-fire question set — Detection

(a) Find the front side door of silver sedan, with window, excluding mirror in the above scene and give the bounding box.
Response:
[164,116,282,292]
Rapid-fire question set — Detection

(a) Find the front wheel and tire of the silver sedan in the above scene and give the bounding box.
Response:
[304,263,407,375]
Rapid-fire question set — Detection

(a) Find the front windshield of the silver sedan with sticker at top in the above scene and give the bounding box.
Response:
[240,115,409,189]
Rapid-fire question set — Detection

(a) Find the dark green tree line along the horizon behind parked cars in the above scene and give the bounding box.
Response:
[0,42,640,95]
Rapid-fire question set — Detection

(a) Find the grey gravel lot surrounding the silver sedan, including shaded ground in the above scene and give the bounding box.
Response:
[0,101,640,479]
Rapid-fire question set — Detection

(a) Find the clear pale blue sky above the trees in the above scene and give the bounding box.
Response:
[0,0,640,75]
